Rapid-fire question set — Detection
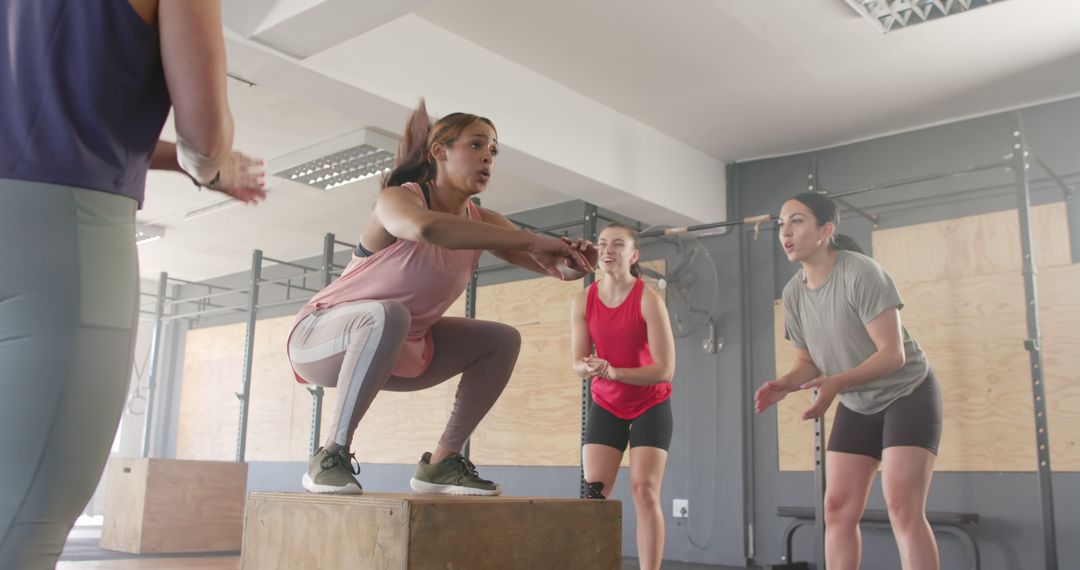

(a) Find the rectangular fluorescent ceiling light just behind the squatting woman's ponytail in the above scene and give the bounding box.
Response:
[269,128,397,190]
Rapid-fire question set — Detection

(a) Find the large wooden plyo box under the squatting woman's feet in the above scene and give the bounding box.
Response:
[241,492,622,570]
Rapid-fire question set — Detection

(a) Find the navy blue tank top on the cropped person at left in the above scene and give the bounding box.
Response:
[0,0,171,204]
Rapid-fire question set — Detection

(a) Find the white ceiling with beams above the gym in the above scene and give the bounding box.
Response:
[138,0,1080,280]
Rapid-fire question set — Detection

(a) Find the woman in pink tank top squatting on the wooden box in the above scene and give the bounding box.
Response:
[288,100,596,494]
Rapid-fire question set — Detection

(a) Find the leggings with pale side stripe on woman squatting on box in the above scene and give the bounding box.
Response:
[289,301,522,452]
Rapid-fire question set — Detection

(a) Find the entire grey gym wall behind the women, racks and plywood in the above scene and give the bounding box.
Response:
[139,99,1080,570]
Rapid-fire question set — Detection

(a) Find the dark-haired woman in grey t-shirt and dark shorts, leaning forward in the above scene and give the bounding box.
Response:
[754,192,942,570]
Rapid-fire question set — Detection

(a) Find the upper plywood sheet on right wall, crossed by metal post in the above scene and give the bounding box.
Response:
[873,202,1071,285]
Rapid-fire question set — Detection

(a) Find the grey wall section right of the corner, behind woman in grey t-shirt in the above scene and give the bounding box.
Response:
[731,95,1080,569]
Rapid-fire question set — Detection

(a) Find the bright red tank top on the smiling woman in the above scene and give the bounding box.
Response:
[585,280,672,420]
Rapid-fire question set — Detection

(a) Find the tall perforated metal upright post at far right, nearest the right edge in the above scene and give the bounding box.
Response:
[1012,112,1057,570]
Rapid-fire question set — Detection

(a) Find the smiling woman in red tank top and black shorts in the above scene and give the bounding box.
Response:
[570,223,675,570]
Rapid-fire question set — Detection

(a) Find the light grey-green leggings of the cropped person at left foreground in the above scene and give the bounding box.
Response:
[0,180,138,570]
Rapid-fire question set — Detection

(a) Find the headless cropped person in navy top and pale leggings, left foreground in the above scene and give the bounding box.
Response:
[0,0,265,570]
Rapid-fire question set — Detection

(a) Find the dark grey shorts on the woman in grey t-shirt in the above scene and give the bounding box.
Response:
[828,370,942,461]
